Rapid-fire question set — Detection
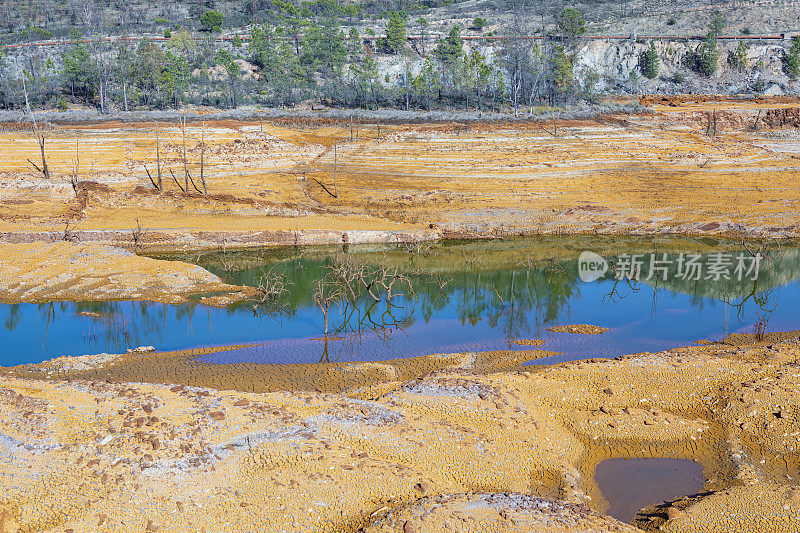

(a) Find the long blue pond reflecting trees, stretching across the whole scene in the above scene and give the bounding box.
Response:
[0,236,800,366]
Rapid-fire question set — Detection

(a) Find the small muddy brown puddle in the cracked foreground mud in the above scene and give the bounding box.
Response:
[594,458,703,523]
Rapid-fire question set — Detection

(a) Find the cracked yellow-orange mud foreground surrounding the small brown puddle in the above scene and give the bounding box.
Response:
[0,332,800,533]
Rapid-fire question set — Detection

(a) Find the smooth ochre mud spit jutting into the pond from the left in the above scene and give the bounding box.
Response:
[0,242,252,305]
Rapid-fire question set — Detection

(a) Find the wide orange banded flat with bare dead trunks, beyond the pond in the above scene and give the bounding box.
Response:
[0,98,800,249]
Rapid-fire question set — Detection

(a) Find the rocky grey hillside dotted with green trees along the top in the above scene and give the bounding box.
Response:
[0,0,800,115]
